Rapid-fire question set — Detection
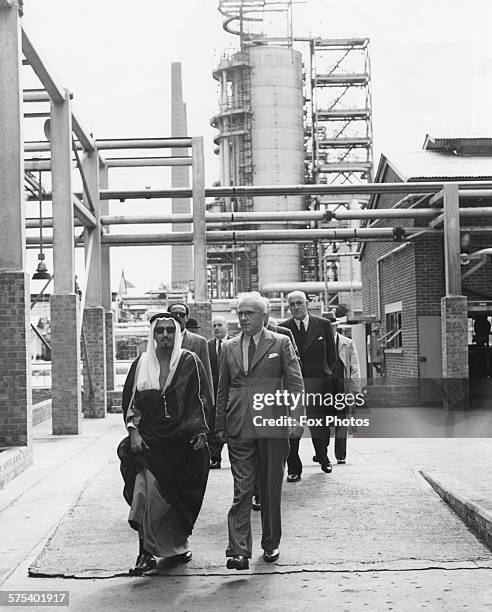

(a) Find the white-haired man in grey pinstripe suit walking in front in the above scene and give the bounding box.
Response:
[216,294,304,570]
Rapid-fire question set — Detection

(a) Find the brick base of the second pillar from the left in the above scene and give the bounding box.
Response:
[50,293,82,435]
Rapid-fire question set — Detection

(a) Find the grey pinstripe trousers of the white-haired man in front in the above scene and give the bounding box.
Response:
[226,436,289,558]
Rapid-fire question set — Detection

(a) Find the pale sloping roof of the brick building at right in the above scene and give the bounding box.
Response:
[382,150,492,181]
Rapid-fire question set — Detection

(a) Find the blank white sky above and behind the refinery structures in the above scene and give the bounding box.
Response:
[23,0,492,290]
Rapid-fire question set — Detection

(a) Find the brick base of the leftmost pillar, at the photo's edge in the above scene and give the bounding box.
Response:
[0,271,32,448]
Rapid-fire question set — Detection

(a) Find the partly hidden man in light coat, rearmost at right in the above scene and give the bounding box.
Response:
[326,311,361,464]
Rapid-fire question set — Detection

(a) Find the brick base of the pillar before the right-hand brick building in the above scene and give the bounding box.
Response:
[441,295,468,410]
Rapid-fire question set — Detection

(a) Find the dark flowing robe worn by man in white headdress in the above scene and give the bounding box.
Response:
[118,351,212,535]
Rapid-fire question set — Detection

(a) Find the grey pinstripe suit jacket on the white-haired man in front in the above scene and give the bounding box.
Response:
[215,329,304,438]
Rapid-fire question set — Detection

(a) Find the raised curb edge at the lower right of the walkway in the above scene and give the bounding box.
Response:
[419,470,492,551]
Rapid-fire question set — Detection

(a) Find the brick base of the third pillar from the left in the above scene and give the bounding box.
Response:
[82,306,107,418]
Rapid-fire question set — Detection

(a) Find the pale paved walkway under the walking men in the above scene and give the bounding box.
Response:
[0,415,492,611]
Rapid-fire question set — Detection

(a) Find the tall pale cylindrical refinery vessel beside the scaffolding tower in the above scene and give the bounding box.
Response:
[249,46,304,290]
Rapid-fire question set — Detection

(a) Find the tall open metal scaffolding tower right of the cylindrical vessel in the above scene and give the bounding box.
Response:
[302,37,373,317]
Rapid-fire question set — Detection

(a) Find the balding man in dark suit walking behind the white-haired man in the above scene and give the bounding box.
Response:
[282,291,337,482]
